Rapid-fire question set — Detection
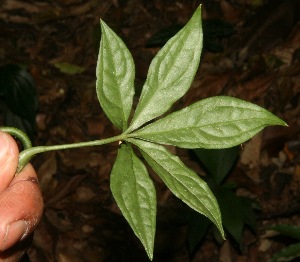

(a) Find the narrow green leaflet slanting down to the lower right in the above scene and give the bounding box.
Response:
[128,139,224,237]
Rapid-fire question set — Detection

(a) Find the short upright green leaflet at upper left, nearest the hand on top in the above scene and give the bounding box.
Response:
[96,21,135,131]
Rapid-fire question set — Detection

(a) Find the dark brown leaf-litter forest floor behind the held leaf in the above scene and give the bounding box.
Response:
[0,0,300,262]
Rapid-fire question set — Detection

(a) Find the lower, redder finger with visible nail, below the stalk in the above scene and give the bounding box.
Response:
[0,164,43,251]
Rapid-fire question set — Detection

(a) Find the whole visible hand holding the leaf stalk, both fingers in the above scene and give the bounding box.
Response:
[0,131,44,262]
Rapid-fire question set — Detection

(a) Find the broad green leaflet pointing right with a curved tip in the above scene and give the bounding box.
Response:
[132,96,287,148]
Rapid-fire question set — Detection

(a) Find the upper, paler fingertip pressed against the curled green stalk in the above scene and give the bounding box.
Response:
[0,131,19,193]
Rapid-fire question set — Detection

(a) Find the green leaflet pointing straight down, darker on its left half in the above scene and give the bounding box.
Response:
[110,144,156,260]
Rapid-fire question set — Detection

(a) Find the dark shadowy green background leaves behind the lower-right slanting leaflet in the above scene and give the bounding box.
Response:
[188,146,259,254]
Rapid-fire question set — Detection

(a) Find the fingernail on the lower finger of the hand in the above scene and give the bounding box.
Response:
[1,220,28,251]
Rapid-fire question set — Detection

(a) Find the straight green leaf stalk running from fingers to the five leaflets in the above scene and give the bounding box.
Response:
[17,134,126,173]
